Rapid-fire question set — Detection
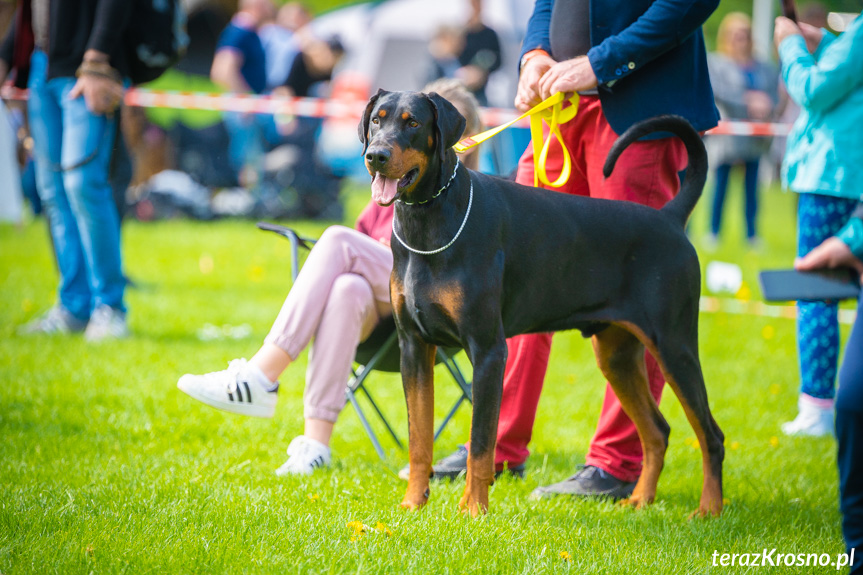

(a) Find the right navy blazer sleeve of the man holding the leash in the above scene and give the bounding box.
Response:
[592,0,719,84]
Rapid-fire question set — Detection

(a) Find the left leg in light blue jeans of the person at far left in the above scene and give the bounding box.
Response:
[27,51,93,321]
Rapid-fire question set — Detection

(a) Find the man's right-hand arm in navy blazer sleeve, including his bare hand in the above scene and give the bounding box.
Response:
[539,0,719,98]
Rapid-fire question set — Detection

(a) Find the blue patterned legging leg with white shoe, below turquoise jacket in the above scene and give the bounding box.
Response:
[782,194,856,436]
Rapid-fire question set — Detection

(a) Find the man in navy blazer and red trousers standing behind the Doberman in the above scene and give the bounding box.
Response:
[426,0,719,498]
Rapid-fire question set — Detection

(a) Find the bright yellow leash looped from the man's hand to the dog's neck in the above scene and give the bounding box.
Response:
[453,92,578,188]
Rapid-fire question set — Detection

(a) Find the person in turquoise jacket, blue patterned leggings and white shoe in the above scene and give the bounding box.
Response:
[774,12,863,436]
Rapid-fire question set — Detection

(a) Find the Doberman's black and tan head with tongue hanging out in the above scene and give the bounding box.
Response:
[359,90,465,206]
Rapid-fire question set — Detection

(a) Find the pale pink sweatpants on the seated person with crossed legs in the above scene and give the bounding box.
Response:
[266,226,393,422]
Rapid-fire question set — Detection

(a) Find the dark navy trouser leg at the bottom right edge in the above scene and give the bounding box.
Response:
[836,298,863,575]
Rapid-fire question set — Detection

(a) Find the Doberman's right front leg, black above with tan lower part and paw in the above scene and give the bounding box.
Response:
[459,336,507,517]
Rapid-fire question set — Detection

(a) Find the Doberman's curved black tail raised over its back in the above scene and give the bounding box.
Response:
[602,116,707,226]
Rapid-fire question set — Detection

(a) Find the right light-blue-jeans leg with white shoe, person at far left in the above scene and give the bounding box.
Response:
[57,78,128,341]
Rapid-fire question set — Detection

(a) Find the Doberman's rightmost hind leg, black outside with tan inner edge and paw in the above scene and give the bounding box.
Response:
[654,326,725,517]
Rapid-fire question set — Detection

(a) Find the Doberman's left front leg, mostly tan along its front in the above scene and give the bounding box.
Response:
[400,334,437,509]
